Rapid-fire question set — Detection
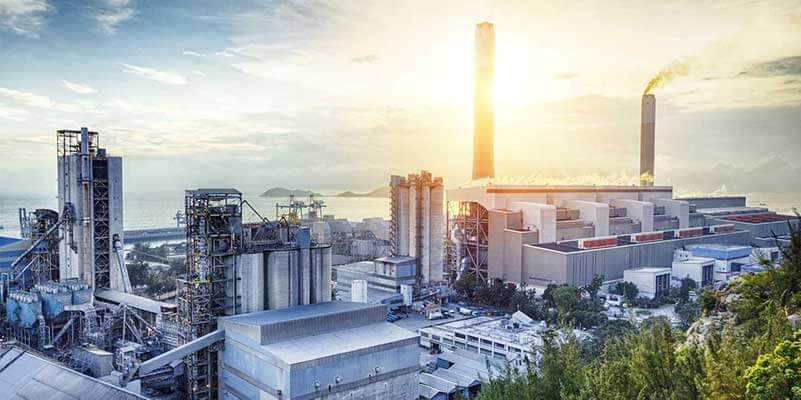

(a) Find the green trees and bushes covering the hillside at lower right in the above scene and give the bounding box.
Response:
[480,219,801,400]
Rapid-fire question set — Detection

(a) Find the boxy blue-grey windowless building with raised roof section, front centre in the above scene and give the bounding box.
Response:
[219,302,419,400]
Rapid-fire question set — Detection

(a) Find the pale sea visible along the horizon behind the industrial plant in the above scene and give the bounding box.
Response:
[0,192,801,237]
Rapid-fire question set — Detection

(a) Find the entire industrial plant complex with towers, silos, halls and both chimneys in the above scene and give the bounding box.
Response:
[0,17,799,400]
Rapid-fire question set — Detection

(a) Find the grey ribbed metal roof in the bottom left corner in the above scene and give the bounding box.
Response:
[0,347,145,400]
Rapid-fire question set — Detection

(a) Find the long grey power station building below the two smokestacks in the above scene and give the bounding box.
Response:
[446,184,798,286]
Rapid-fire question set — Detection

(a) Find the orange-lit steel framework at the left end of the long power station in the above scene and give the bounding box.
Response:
[447,201,489,282]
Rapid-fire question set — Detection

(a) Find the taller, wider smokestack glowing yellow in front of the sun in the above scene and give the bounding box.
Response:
[473,22,495,179]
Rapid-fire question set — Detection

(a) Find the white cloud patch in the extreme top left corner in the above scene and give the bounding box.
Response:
[0,0,53,39]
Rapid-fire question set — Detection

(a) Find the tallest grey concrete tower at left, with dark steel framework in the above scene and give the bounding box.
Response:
[57,128,124,291]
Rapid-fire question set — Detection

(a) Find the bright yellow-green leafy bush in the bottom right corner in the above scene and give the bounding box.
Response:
[745,332,801,400]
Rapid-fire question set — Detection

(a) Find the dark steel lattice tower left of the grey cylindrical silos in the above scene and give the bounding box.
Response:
[178,189,242,399]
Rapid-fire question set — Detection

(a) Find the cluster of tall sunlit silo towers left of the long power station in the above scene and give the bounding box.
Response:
[389,171,444,285]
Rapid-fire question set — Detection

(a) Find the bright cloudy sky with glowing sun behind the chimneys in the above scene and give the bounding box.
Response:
[0,0,801,194]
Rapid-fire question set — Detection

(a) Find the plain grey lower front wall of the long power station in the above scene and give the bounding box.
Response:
[523,231,749,286]
